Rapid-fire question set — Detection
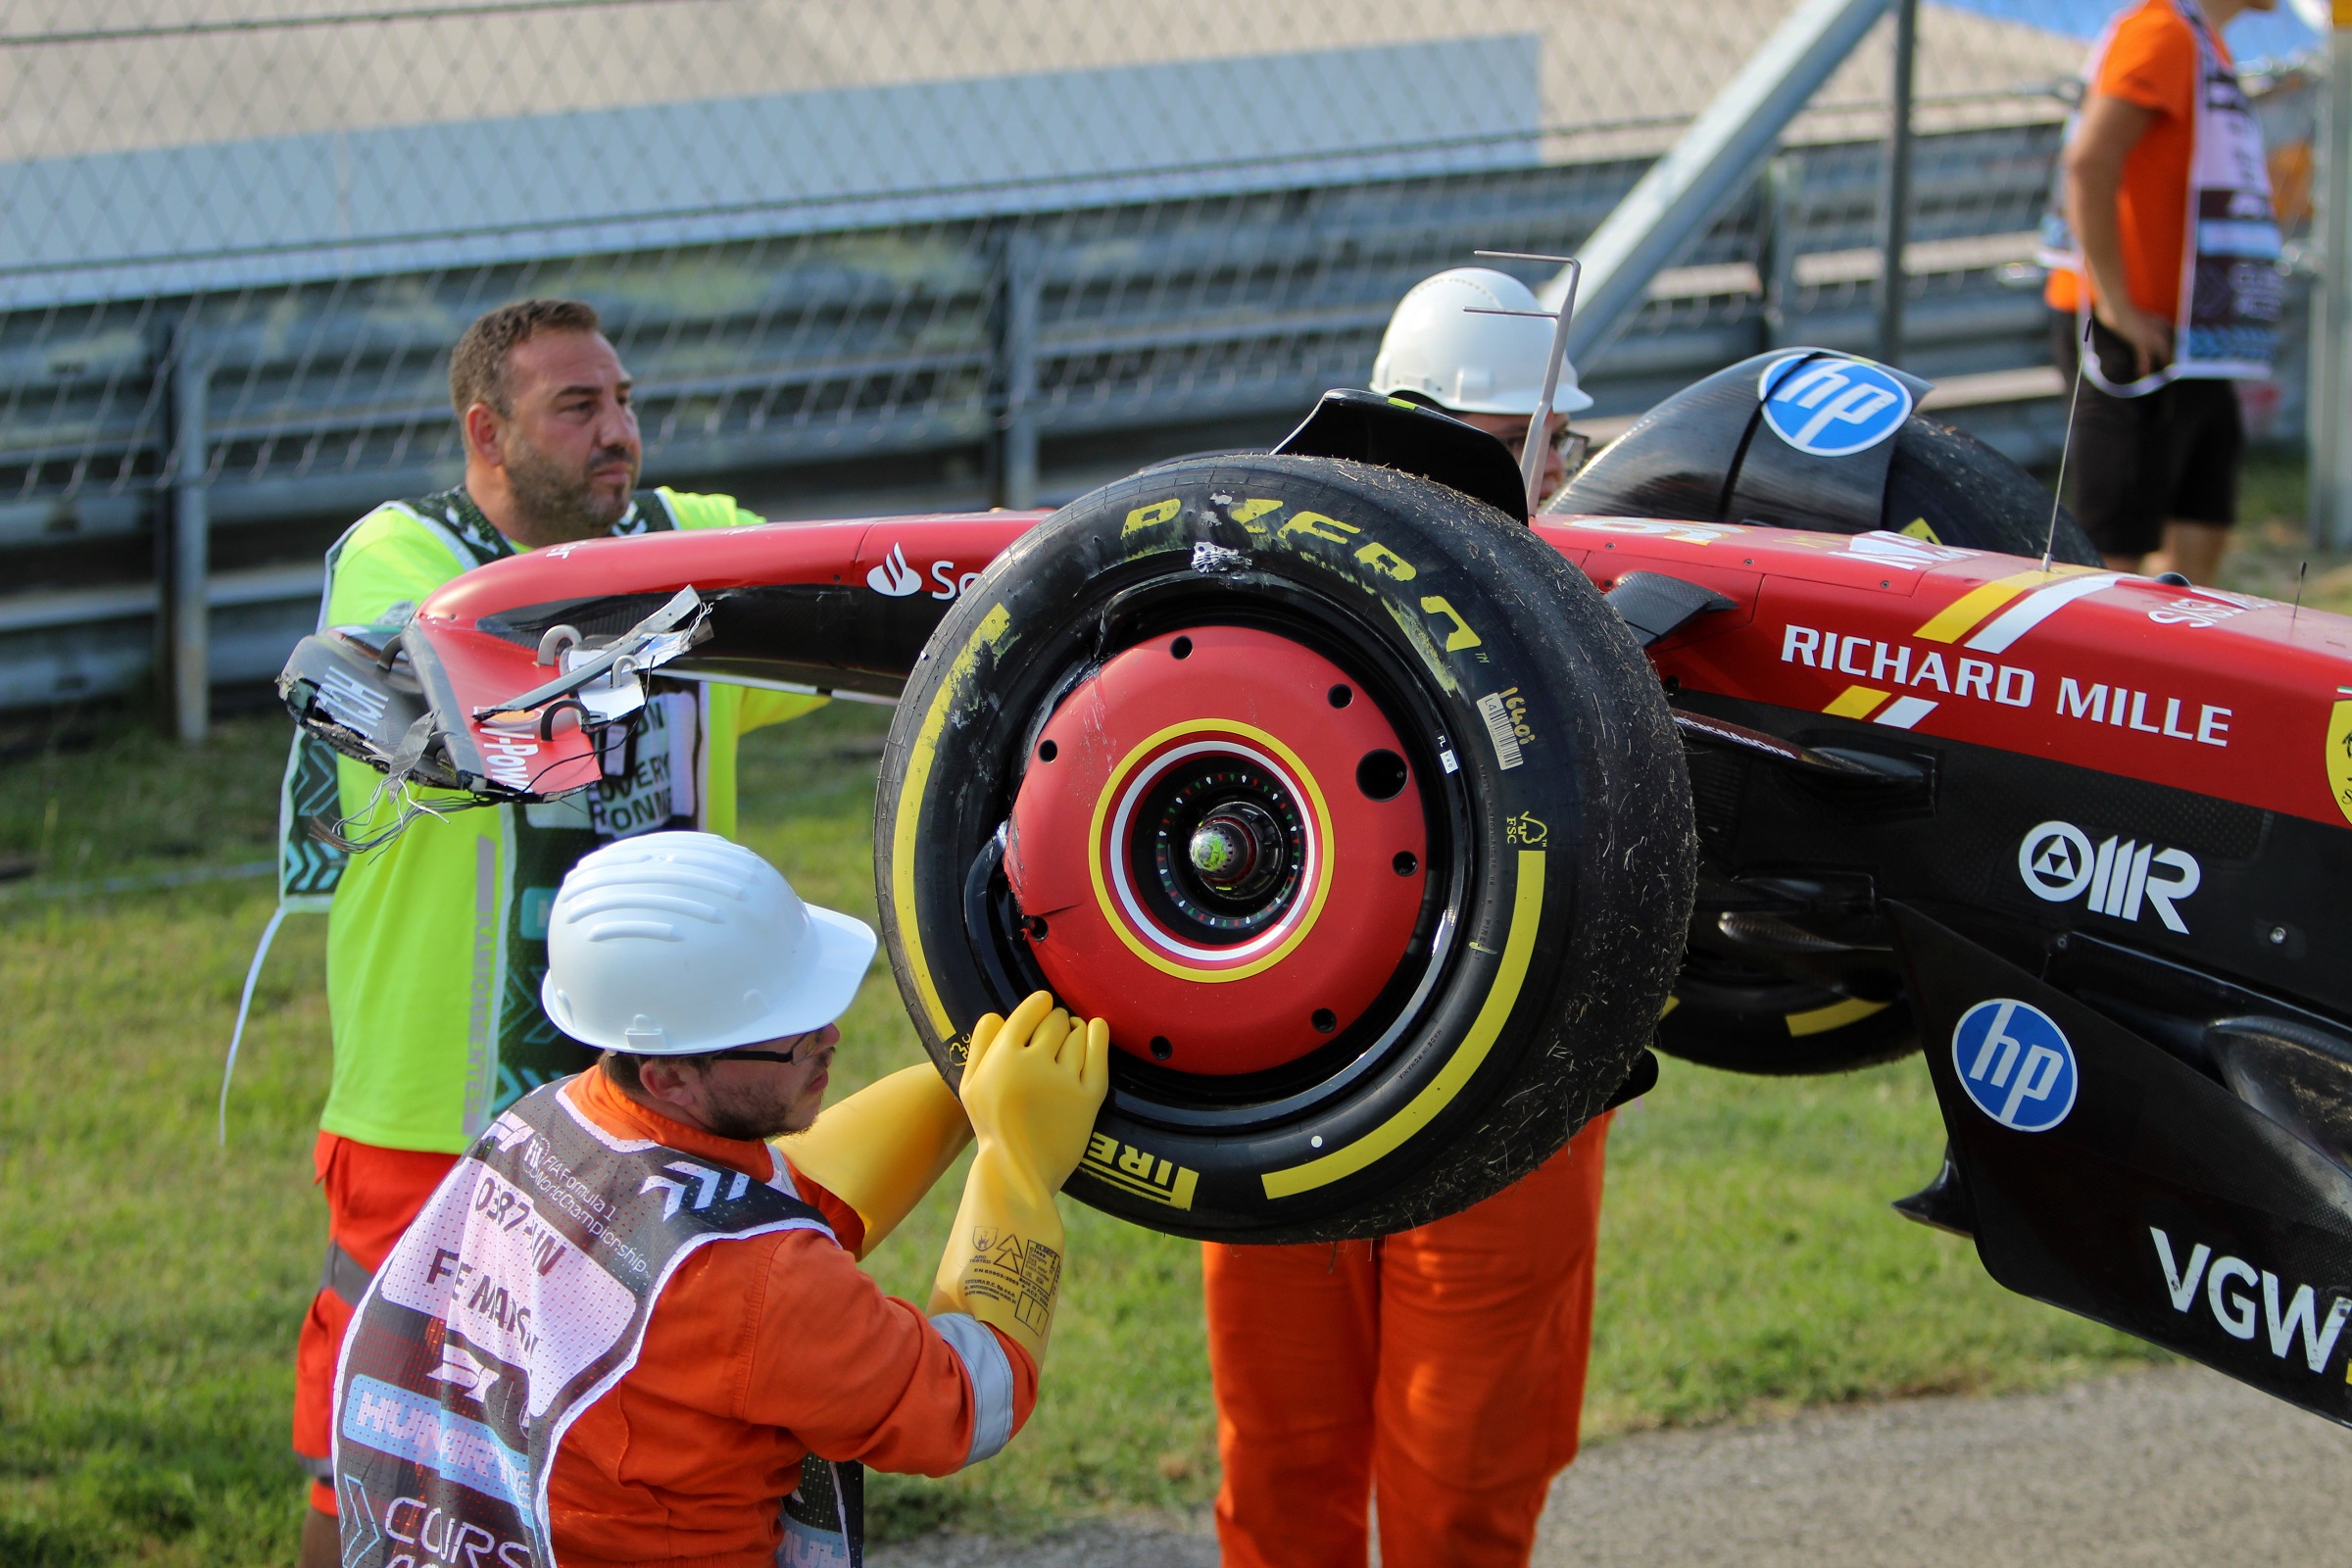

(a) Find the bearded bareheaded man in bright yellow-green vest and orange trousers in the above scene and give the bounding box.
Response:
[280,299,821,1568]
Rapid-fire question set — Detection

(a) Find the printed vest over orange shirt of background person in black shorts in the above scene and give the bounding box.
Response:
[2039,0,2286,397]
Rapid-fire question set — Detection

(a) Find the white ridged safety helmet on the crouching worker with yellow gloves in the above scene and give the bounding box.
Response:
[539,832,875,1055]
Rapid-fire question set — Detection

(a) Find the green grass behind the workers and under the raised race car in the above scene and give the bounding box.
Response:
[0,708,2154,1568]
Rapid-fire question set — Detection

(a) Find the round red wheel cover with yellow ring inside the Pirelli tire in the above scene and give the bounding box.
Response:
[1004,625,1428,1077]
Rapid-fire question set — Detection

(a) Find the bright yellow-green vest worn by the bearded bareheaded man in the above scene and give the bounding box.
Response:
[260,487,823,1154]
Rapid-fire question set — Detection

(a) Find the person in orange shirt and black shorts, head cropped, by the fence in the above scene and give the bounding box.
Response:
[2044,0,2281,583]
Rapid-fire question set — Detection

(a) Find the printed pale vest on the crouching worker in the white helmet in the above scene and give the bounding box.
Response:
[334,1084,863,1568]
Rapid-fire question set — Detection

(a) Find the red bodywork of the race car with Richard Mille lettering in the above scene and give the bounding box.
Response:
[418,513,2352,823]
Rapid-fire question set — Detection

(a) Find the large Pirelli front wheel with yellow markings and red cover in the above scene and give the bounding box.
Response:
[875,456,1695,1242]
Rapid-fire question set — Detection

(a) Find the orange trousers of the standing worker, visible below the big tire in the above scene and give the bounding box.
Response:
[1201,1116,1609,1568]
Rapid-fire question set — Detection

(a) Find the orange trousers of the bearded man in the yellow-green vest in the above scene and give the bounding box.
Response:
[294,1133,457,1514]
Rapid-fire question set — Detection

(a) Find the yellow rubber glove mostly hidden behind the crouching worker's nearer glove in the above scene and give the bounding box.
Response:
[776,1029,1004,1257]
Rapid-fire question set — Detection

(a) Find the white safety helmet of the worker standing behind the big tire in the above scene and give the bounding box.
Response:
[1371,266,1592,416]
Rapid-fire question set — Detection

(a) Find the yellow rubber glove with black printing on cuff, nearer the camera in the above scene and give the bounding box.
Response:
[931,992,1110,1366]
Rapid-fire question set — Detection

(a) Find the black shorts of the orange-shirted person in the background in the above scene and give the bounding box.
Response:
[2051,311,2246,555]
